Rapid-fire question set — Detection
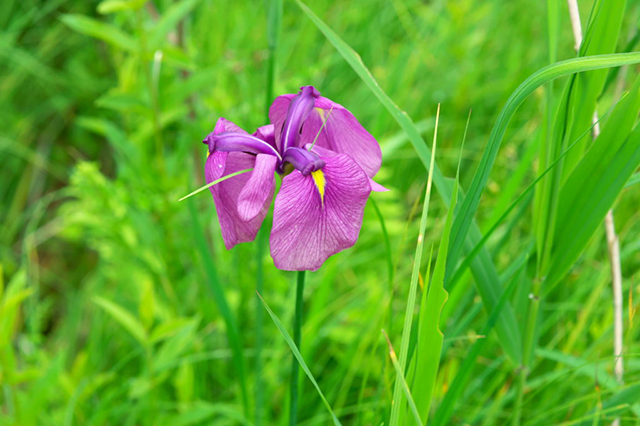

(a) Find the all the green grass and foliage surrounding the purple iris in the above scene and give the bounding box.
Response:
[0,0,640,426]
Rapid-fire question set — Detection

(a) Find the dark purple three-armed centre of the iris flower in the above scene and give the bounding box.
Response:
[203,86,325,176]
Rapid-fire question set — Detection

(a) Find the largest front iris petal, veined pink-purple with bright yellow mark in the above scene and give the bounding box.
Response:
[270,154,371,271]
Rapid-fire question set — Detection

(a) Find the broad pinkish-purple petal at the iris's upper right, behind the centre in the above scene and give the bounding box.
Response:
[300,97,382,177]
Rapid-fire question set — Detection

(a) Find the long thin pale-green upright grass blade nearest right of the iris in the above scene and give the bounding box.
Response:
[389,105,440,426]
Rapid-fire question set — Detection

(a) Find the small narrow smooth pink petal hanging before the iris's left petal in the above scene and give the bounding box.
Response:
[238,154,277,221]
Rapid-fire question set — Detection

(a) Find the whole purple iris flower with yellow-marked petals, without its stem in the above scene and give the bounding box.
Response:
[204,86,386,271]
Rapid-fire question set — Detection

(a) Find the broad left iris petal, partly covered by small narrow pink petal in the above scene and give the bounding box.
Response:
[205,151,268,250]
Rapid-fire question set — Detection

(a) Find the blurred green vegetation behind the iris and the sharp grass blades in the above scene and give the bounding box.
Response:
[0,0,640,426]
